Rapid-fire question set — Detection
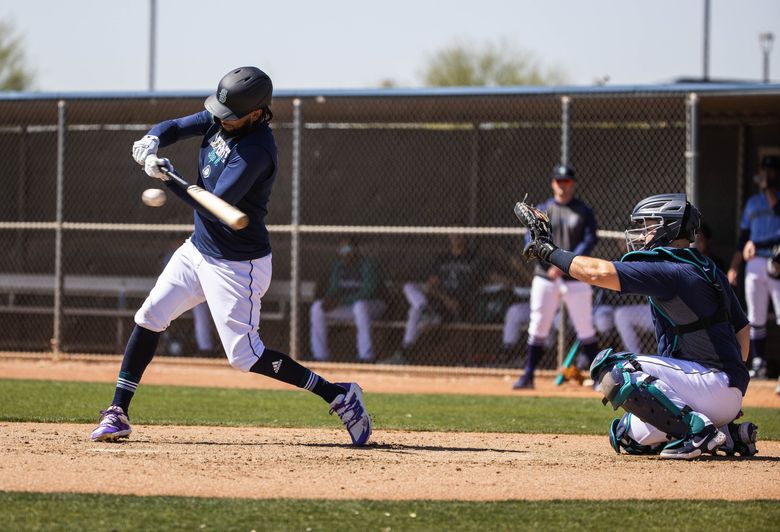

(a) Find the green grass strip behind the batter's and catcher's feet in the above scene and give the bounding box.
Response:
[0,380,780,438]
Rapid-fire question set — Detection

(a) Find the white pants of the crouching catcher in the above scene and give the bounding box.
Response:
[628,355,742,445]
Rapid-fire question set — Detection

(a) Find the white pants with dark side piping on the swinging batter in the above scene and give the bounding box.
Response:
[135,239,271,371]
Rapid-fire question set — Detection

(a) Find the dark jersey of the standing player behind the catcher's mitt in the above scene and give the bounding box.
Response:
[525,198,598,279]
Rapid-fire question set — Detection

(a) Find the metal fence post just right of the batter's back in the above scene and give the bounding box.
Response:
[290,98,303,359]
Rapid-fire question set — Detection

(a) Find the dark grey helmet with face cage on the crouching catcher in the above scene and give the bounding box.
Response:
[626,194,701,251]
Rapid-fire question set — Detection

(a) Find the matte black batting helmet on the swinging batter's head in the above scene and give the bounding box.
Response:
[204,67,273,120]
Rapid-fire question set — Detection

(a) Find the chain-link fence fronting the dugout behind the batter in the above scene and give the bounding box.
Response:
[0,86,760,367]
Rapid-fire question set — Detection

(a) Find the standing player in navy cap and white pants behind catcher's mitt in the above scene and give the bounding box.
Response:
[512,165,599,390]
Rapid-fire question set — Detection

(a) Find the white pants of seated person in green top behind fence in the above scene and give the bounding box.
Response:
[310,299,387,361]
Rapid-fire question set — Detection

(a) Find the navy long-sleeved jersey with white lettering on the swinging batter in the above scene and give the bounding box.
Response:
[148,111,278,260]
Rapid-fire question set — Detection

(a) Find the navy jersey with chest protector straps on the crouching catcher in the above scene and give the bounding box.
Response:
[613,248,750,394]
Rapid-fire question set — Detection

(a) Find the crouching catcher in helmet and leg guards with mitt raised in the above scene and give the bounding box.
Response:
[515,194,758,460]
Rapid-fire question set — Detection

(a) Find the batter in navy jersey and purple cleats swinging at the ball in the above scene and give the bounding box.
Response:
[92,67,371,445]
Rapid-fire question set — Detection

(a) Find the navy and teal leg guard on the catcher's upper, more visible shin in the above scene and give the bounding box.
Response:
[598,357,704,438]
